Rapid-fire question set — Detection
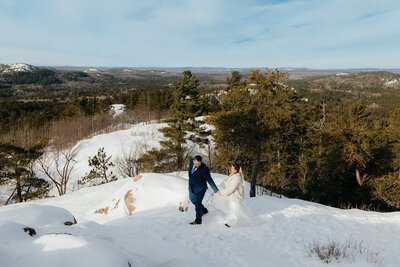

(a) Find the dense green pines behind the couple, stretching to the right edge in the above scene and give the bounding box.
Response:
[3,69,400,211]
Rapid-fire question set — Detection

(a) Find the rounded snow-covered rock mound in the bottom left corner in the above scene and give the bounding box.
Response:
[0,203,140,267]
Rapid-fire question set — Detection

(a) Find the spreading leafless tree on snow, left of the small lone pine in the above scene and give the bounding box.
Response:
[37,145,81,196]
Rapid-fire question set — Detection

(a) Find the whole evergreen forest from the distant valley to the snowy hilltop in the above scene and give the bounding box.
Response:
[0,65,400,211]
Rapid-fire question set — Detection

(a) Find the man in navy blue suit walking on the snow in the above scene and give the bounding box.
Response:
[188,156,221,225]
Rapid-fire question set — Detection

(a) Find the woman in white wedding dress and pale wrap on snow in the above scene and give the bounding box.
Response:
[213,163,250,227]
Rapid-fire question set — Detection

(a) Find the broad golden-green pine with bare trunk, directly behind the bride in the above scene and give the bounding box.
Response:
[210,68,300,197]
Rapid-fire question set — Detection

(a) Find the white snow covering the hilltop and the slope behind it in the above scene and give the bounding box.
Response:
[0,120,400,267]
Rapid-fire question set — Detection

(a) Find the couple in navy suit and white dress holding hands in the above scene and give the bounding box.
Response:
[188,156,249,227]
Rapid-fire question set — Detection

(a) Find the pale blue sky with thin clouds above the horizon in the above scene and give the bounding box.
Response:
[0,0,400,68]
